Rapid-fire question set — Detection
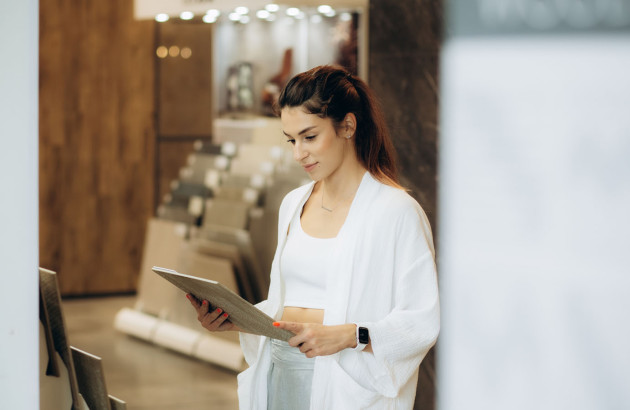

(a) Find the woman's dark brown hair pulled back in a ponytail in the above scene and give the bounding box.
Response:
[276,65,400,188]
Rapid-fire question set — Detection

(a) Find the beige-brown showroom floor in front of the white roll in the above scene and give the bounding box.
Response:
[63,296,238,410]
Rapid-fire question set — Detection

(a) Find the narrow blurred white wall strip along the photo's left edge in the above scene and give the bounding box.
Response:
[0,0,39,409]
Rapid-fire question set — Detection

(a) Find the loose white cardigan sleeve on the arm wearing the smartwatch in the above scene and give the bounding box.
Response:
[350,199,440,397]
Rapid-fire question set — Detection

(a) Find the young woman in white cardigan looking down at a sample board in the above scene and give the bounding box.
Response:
[191,66,439,409]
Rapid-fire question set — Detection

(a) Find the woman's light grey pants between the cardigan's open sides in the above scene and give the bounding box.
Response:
[267,339,315,410]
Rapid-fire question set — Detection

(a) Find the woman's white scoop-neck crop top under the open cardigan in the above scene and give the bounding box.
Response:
[280,208,337,309]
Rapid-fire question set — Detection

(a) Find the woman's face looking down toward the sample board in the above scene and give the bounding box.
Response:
[280,107,351,181]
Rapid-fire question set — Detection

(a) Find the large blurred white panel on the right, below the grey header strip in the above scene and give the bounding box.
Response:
[438,33,630,410]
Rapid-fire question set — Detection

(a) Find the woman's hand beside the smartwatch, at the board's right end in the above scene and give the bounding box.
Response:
[273,322,357,358]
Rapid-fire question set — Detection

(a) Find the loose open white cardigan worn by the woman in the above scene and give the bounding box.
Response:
[238,172,440,410]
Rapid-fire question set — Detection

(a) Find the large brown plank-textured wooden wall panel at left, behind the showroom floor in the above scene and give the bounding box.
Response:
[39,0,156,295]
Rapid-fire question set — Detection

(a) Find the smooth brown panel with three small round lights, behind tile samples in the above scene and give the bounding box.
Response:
[155,19,214,206]
